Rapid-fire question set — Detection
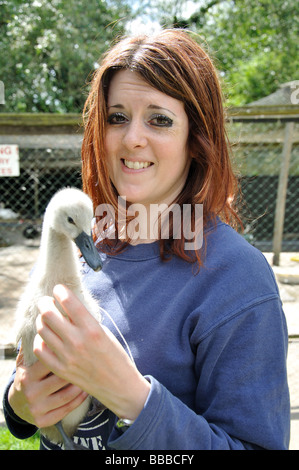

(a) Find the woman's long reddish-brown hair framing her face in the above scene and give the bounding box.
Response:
[82,29,241,266]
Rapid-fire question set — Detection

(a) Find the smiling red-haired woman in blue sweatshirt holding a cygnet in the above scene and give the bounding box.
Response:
[4,30,289,450]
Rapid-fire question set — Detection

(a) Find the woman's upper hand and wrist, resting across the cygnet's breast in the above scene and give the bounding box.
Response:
[34,285,150,419]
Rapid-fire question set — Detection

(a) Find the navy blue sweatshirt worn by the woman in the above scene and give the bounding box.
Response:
[4,222,290,450]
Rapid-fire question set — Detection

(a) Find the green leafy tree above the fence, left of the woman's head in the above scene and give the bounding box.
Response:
[0,0,130,112]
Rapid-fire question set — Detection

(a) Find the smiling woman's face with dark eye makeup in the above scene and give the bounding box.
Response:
[105,70,190,206]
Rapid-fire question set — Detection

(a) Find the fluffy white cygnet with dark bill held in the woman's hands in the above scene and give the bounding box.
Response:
[16,188,102,450]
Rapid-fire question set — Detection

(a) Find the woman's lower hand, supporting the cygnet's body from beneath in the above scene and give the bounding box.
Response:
[8,348,87,428]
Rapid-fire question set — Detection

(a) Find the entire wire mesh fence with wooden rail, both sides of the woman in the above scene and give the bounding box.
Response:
[0,114,299,258]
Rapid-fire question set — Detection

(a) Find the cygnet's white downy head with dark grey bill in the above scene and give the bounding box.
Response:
[44,188,102,271]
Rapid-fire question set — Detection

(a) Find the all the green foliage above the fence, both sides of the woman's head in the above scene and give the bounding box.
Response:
[0,0,299,108]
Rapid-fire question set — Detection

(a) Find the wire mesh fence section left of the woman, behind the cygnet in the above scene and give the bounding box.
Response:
[0,129,82,246]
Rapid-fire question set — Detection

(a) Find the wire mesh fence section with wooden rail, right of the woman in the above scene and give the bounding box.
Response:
[230,119,299,255]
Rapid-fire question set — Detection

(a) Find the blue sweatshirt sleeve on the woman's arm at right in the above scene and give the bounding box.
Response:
[108,297,290,450]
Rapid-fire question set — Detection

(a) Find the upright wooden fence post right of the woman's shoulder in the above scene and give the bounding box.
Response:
[273,122,294,266]
